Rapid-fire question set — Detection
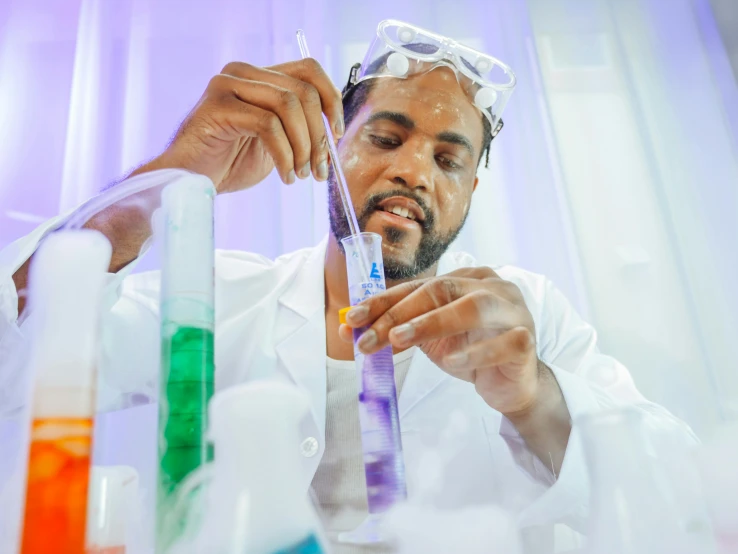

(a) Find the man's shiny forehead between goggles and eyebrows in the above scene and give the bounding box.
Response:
[365,67,483,144]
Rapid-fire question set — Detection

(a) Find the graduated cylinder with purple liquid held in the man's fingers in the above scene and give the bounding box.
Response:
[339,233,407,544]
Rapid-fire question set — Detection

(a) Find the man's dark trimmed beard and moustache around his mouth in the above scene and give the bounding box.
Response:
[328,177,469,281]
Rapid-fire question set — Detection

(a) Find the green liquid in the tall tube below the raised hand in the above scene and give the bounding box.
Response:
[157,323,215,552]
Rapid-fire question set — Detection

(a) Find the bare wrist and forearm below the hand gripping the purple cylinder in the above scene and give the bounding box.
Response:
[505,361,571,475]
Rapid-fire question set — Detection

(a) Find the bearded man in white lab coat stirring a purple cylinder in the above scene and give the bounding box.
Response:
[0,19,694,552]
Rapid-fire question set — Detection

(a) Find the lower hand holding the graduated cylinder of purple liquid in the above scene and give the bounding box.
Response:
[339,267,548,419]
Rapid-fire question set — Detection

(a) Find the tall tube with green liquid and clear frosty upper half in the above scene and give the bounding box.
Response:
[156,175,215,552]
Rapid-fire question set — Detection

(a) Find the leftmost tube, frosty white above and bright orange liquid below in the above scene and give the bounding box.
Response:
[19,230,112,554]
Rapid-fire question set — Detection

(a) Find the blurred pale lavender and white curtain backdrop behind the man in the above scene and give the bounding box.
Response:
[0,0,738,440]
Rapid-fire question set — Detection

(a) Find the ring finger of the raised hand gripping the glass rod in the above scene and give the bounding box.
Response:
[211,71,312,179]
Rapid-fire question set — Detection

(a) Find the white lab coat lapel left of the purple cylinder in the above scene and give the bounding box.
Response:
[275,235,327,436]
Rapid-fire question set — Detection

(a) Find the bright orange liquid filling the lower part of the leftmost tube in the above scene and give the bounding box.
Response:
[21,418,92,554]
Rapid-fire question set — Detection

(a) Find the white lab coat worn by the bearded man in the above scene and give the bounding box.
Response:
[0,205,696,548]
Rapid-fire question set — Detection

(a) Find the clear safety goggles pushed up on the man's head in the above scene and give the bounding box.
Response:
[343,19,515,138]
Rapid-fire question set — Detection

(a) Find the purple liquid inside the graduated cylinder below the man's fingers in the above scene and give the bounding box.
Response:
[354,329,407,514]
